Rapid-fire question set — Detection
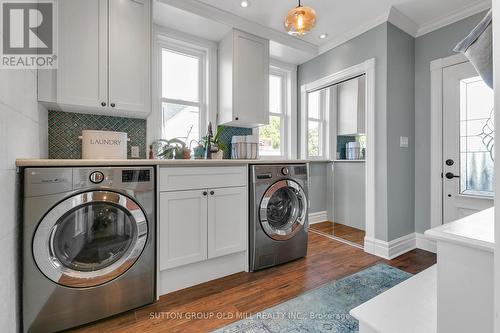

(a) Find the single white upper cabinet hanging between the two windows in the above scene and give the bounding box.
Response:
[219,29,269,128]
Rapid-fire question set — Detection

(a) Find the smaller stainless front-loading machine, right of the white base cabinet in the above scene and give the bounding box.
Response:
[249,164,309,271]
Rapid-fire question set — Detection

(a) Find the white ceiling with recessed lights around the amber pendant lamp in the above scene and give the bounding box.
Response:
[154,0,491,64]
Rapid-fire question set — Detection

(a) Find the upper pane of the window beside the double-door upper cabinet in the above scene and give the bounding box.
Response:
[162,49,200,102]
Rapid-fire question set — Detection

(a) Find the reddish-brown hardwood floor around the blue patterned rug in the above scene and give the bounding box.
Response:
[75,233,436,333]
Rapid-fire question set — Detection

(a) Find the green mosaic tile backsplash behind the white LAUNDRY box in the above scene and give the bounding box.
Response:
[49,111,147,159]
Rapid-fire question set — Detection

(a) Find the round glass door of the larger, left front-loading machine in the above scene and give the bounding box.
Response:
[33,191,148,288]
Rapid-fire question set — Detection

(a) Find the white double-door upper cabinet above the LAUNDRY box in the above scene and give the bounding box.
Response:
[38,0,151,118]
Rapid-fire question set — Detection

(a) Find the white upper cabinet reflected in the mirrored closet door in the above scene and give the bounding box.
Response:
[337,75,365,135]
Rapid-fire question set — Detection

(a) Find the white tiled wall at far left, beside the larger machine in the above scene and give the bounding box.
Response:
[0,70,47,332]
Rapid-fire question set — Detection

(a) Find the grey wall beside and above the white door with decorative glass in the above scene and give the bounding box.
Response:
[415,12,486,233]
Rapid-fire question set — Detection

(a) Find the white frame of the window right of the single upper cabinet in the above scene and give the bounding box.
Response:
[254,59,297,160]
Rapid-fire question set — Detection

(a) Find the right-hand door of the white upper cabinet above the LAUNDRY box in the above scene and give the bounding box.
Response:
[109,0,151,115]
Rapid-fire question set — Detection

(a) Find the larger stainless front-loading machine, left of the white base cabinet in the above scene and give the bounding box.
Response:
[22,167,156,332]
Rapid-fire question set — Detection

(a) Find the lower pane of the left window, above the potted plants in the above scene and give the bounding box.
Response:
[162,103,200,146]
